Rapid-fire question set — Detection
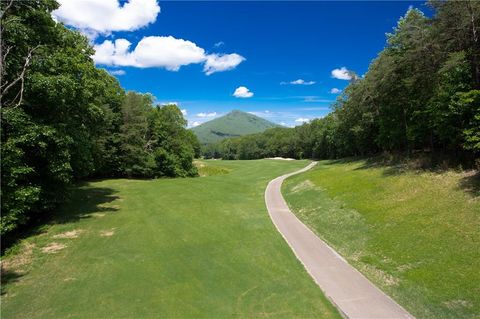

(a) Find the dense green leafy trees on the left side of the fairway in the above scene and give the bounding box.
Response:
[0,0,199,239]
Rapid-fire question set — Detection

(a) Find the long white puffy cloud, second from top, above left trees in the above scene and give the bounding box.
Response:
[92,36,245,75]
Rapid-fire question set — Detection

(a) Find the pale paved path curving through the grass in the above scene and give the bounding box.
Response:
[265,162,414,319]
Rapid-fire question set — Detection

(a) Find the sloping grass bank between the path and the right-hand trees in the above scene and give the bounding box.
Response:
[282,160,480,318]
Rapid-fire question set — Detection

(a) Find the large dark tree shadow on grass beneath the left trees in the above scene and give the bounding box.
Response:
[1,182,119,255]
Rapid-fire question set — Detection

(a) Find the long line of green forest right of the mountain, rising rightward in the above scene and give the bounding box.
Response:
[203,1,480,165]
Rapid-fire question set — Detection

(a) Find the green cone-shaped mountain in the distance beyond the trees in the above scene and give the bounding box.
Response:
[191,110,280,144]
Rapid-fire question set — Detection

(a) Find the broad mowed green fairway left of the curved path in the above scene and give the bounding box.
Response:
[1,160,340,319]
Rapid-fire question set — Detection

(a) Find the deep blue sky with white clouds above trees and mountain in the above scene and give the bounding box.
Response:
[54,0,427,126]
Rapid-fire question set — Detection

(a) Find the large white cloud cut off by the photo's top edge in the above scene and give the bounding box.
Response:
[52,0,160,35]
